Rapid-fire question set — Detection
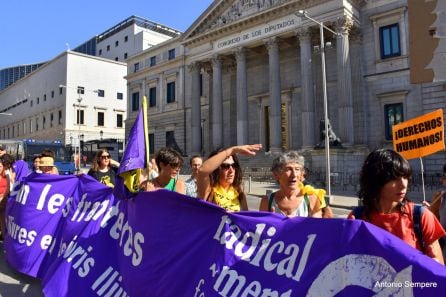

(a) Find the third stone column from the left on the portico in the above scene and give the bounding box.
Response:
[235,47,248,145]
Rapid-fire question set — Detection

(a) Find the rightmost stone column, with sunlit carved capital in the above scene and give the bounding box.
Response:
[335,18,354,145]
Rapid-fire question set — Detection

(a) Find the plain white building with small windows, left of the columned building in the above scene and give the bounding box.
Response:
[0,51,127,145]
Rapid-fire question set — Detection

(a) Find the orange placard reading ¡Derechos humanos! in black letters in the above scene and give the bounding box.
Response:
[392,109,444,159]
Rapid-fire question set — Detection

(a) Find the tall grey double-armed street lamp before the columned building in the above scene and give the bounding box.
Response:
[295,10,339,199]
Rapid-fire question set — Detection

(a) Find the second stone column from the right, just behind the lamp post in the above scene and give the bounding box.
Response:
[297,28,318,149]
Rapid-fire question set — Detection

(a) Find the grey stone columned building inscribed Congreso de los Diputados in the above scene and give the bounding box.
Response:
[126,0,446,173]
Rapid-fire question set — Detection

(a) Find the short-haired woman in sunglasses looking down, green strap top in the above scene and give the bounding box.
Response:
[142,147,186,194]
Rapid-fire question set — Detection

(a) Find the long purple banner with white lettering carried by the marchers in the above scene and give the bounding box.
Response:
[5,174,446,297]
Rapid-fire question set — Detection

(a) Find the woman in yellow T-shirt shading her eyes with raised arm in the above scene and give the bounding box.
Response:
[197,144,262,212]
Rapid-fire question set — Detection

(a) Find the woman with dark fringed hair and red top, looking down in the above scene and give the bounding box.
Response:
[348,149,446,264]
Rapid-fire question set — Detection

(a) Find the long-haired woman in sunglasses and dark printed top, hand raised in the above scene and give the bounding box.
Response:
[88,149,119,188]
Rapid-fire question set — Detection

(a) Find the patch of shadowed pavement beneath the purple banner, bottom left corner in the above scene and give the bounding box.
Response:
[0,242,44,297]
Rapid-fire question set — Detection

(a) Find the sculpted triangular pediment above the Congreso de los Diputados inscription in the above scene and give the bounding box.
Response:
[183,0,296,40]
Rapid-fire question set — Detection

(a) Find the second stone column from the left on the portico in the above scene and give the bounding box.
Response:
[211,55,223,150]
